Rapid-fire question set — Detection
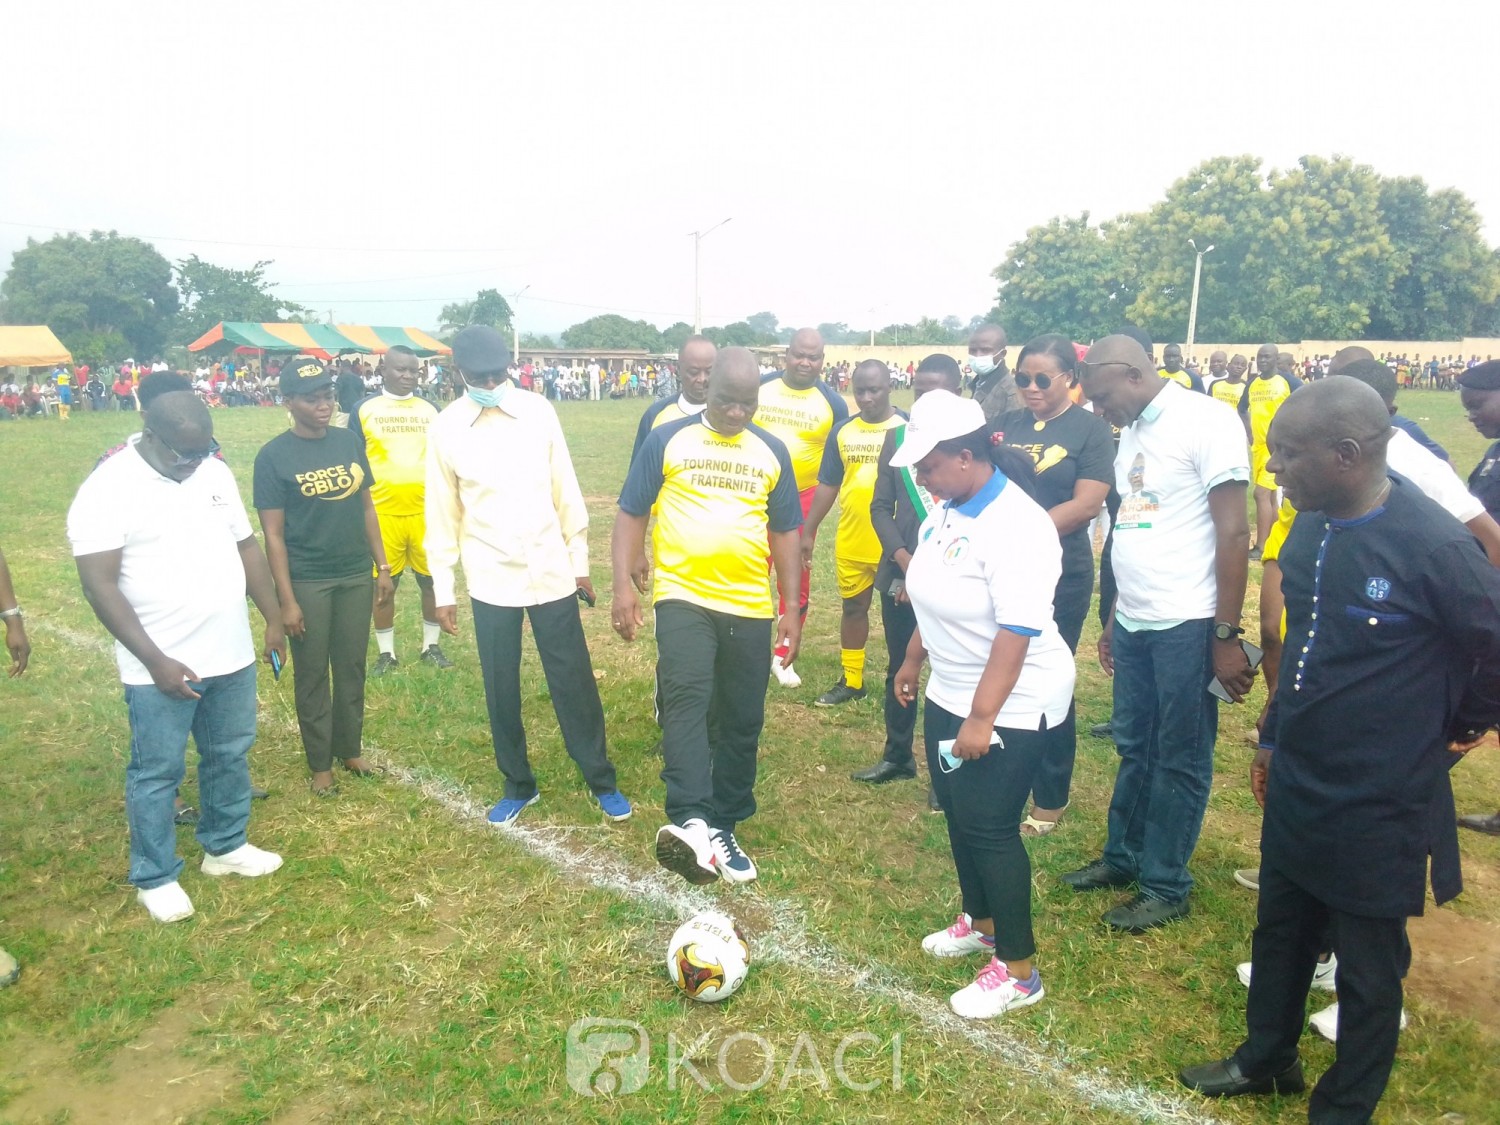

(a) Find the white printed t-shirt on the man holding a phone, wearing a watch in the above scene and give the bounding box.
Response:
[1113,383,1250,626]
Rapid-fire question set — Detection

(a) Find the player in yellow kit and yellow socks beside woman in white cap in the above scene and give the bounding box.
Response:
[803,360,906,707]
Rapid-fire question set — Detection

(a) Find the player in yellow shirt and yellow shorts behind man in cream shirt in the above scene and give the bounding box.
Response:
[350,344,453,677]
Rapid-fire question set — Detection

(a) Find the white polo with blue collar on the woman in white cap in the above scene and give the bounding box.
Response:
[906,473,1076,731]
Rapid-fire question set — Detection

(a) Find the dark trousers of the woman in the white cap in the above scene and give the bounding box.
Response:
[923,699,1061,962]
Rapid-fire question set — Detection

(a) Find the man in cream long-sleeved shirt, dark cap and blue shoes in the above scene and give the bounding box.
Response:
[426,324,630,825]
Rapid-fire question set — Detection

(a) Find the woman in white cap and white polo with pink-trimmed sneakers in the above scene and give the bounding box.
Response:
[891,390,1074,1019]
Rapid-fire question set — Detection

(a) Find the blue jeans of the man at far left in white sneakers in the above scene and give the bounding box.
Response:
[125,663,255,891]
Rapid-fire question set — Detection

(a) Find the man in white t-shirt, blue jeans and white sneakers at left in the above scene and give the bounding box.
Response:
[68,390,287,923]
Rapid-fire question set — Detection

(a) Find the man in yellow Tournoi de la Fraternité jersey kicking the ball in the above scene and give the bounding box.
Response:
[611,348,803,884]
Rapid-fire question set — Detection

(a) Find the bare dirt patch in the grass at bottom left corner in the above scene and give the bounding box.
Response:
[0,999,242,1125]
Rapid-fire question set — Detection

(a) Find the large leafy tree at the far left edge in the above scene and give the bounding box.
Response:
[0,231,179,362]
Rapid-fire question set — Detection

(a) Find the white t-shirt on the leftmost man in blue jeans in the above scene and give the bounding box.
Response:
[68,449,255,686]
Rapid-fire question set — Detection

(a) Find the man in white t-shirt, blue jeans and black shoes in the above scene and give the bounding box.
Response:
[1064,336,1256,933]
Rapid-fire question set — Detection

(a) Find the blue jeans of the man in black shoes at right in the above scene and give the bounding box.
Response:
[1104,618,1218,903]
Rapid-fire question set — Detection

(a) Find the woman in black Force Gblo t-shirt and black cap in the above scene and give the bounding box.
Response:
[255,356,395,797]
